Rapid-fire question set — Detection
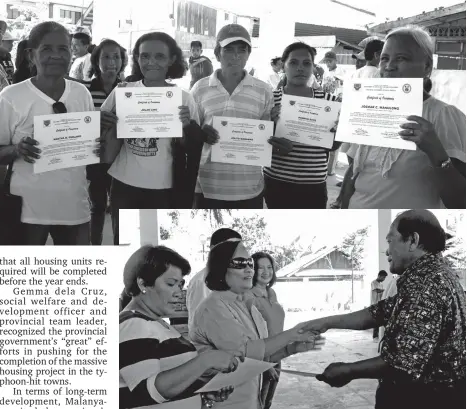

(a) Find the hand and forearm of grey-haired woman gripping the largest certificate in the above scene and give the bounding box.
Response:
[399,115,449,166]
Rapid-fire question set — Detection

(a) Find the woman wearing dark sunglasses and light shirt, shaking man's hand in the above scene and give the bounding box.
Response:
[189,239,323,409]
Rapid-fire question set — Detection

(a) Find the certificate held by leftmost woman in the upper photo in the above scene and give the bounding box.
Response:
[34,111,101,173]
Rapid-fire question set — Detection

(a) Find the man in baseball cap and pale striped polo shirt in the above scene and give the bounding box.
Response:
[191,24,278,209]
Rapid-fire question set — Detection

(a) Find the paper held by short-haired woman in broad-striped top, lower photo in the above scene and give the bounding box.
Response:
[196,358,276,393]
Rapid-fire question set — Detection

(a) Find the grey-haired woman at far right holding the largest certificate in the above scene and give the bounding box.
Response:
[343,26,466,209]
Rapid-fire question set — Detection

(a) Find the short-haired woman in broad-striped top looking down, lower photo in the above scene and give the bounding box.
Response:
[119,246,243,409]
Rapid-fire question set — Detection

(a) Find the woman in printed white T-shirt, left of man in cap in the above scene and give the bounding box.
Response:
[101,32,203,244]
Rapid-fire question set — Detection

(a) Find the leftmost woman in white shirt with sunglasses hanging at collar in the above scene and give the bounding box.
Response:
[0,21,99,245]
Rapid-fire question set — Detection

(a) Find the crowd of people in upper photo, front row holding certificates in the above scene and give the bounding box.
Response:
[0,21,465,245]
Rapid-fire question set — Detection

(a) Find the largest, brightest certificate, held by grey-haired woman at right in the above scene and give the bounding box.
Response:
[336,78,423,150]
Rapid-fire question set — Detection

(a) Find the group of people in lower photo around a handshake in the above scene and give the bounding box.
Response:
[120,210,466,409]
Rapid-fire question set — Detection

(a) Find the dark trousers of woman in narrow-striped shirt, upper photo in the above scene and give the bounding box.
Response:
[264,176,328,209]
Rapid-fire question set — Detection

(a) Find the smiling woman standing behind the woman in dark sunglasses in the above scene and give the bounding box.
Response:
[245,252,285,409]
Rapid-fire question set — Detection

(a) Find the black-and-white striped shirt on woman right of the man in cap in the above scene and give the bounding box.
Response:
[264,88,337,184]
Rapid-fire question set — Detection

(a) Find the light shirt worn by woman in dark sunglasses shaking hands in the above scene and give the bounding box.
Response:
[189,291,268,409]
